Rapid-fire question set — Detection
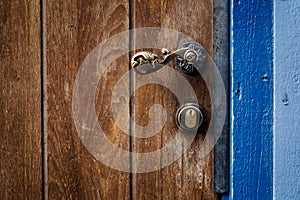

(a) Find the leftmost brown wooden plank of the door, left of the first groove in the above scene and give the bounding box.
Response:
[0,0,42,199]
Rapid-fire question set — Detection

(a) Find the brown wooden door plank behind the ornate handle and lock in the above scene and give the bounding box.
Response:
[131,0,217,199]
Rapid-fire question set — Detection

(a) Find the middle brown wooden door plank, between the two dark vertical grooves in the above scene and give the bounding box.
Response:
[45,0,130,199]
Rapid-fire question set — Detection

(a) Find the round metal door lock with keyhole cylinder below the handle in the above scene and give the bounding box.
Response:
[176,103,203,133]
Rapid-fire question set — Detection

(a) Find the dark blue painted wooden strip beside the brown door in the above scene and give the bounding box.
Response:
[223,0,273,200]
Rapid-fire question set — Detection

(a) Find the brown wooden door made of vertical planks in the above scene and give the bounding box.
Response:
[0,0,225,199]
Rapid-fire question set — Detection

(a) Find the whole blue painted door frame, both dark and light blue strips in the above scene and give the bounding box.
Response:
[223,0,300,200]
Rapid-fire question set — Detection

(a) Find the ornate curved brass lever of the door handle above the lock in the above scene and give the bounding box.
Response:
[131,48,197,75]
